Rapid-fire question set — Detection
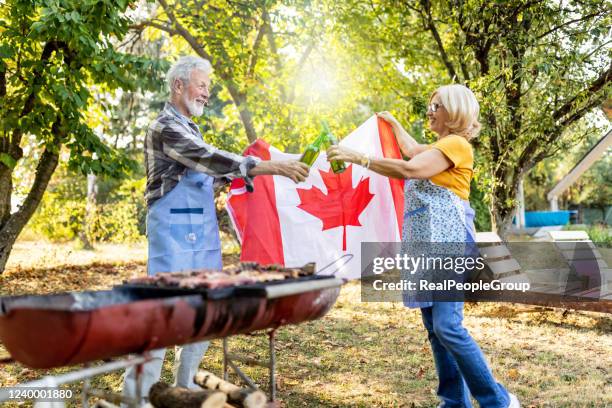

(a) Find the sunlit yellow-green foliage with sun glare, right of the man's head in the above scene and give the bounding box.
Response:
[143,0,382,153]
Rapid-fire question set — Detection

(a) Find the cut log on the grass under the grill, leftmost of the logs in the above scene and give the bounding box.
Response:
[149,382,227,408]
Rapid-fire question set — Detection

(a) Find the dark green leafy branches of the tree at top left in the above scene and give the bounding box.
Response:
[0,0,167,177]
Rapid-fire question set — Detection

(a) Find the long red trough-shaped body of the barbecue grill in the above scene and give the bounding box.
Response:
[0,276,342,368]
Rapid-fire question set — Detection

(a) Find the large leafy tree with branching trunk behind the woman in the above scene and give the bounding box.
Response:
[330,0,612,230]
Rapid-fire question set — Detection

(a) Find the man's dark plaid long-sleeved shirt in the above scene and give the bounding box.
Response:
[144,102,260,207]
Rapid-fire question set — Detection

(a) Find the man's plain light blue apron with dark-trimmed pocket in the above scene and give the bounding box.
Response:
[147,169,222,275]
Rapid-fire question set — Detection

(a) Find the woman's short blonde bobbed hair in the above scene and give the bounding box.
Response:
[429,84,480,140]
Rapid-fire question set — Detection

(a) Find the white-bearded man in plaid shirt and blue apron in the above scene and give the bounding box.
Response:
[124,56,308,404]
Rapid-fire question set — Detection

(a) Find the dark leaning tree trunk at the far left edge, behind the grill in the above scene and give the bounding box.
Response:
[0,144,60,274]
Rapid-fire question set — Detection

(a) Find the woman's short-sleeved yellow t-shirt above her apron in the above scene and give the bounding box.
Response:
[430,135,474,200]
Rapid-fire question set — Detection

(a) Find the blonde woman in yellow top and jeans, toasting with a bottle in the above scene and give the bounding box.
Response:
[327,85,520,408]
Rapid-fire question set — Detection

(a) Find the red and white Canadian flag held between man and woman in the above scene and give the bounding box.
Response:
[227,116,404,279]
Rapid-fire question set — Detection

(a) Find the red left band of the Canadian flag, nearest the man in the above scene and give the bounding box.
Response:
[228,139,285,265]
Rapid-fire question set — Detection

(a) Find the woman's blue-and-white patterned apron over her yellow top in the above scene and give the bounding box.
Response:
[401,180,476,308]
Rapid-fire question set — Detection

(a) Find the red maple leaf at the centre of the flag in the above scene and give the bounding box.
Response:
[297,164,374,251]
